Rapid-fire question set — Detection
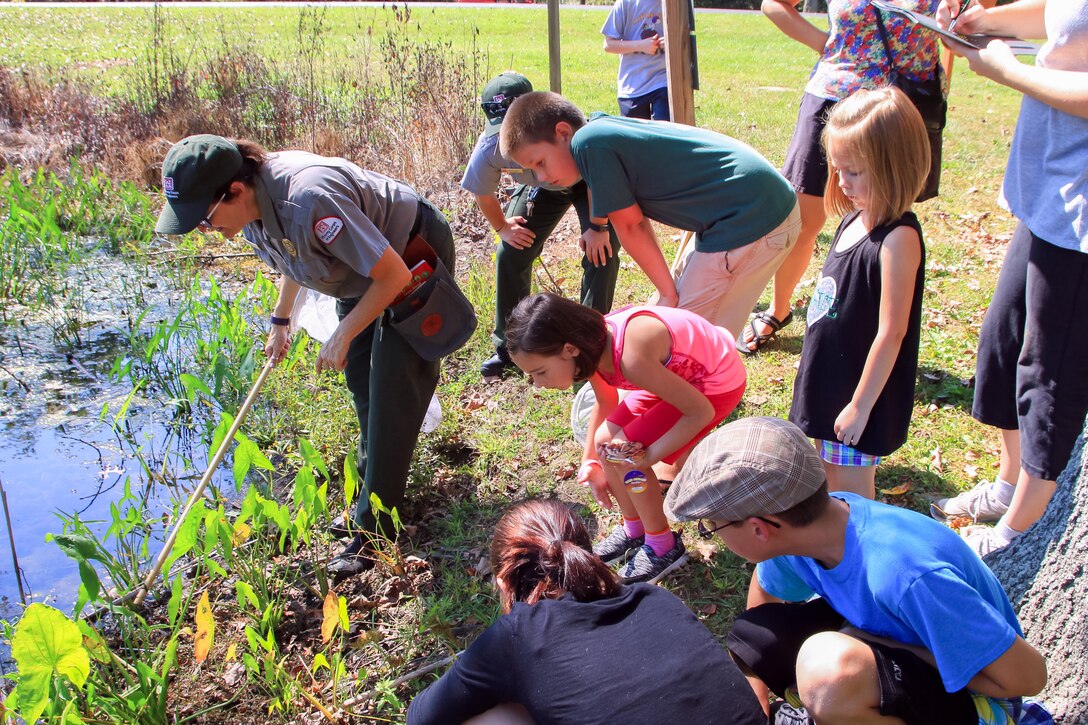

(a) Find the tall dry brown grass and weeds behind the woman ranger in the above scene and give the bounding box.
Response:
[0,4,482,192]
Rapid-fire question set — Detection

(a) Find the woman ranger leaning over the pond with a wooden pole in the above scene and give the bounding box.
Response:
[156,135,454,576]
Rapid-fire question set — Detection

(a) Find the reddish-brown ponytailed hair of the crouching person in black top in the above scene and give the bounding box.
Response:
[491,499,619,612]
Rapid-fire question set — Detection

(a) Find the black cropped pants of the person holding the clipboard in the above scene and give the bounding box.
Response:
[972,223,1088,481]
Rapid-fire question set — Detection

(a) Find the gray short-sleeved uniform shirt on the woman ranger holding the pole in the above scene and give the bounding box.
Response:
[243,151,419,298]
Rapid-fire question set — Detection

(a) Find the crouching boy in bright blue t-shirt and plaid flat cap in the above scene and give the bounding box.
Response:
[666,418,1047,725]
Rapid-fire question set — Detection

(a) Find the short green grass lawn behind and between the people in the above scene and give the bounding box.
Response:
[0,4,1018,722]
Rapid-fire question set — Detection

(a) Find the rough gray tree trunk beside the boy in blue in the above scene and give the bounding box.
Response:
[986,420,1088,723]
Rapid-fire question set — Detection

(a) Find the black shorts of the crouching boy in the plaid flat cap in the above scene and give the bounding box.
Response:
[726,599,978,725]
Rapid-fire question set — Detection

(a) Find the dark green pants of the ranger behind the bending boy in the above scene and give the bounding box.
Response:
[492,177,619,345]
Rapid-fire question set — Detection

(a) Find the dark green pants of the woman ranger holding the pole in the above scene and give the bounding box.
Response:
[336,202,456,539]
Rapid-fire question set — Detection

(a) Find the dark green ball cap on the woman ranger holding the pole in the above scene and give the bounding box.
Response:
[154,134,242,234]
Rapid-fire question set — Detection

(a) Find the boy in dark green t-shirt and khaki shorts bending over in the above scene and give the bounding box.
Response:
[499,93,801,337]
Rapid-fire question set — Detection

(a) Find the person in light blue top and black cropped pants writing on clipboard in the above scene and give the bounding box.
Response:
[931,0,1088,554]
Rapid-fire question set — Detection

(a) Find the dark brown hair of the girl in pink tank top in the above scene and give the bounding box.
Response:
[506,292,608,380]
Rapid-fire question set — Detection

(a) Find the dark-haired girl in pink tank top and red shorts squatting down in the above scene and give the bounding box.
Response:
[506,293,746,582]
